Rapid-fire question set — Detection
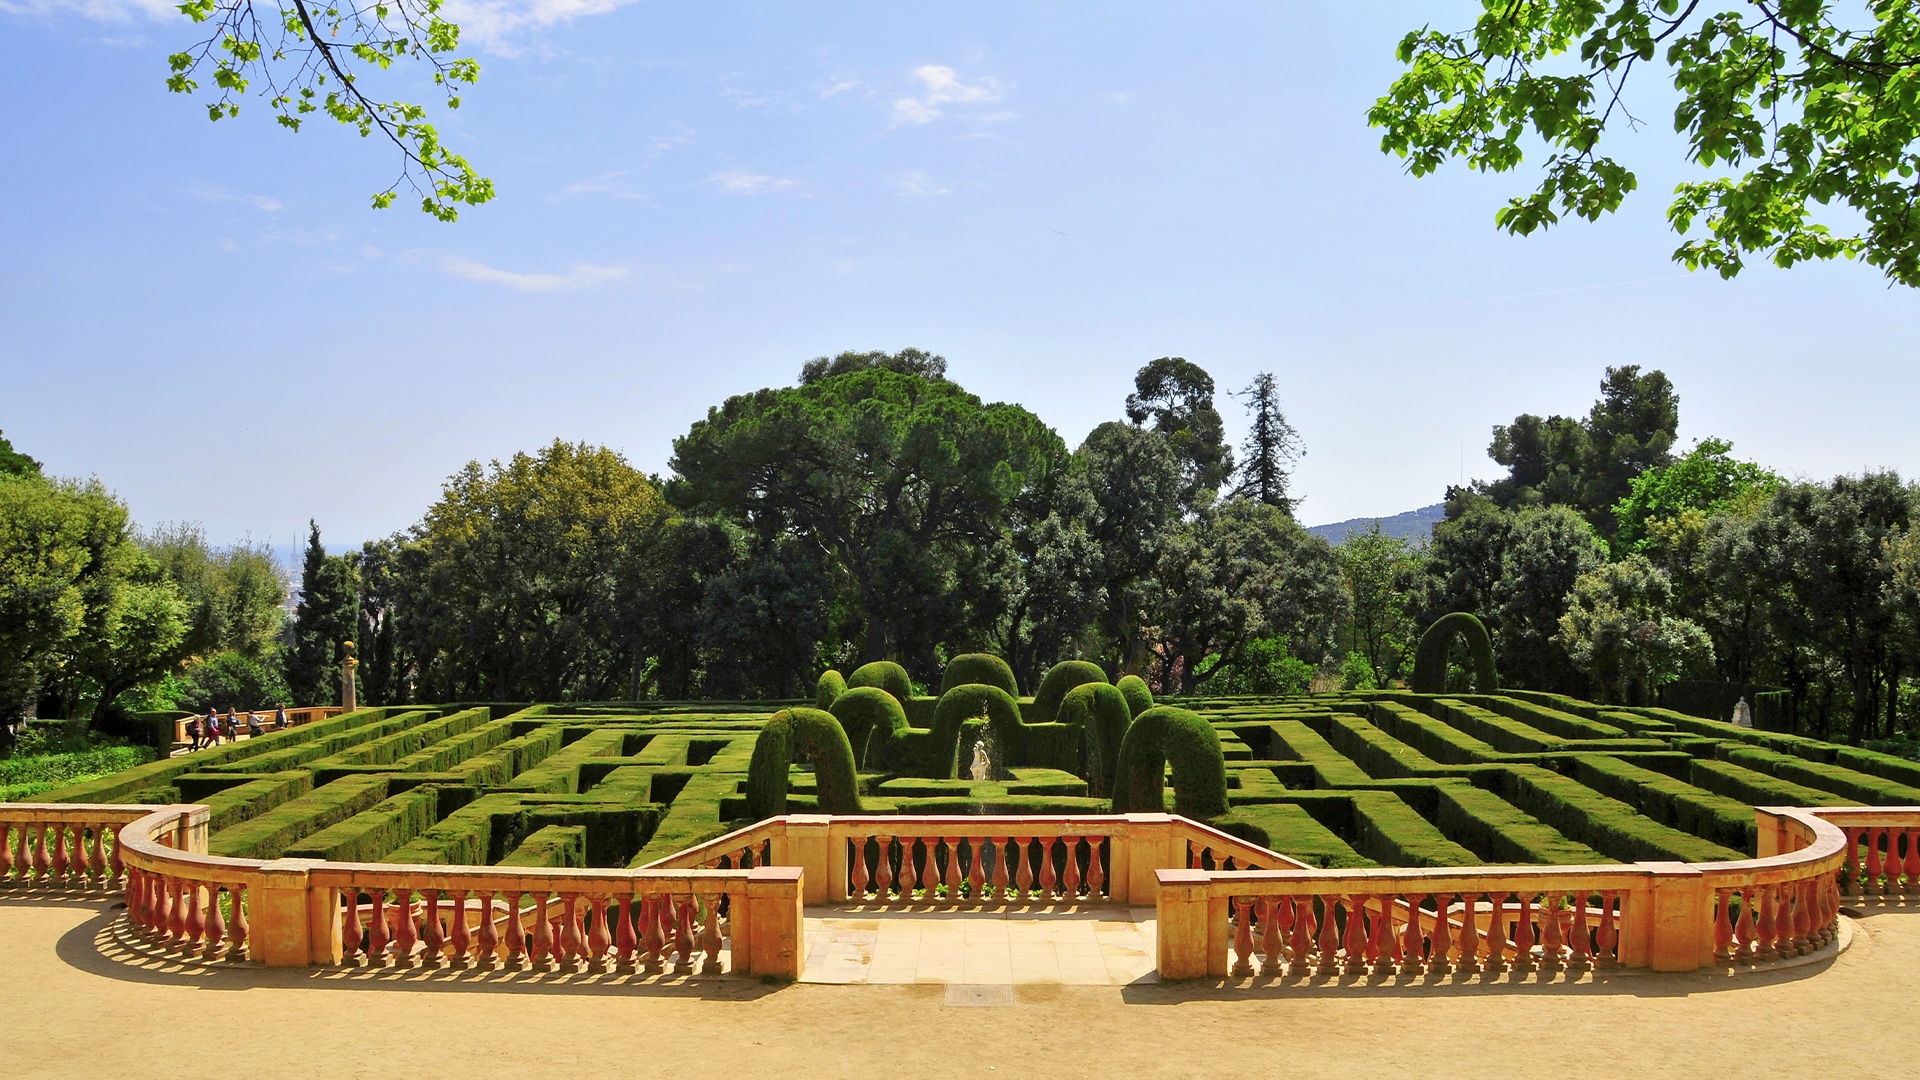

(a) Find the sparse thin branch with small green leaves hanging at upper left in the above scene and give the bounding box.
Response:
[167,0,493,221]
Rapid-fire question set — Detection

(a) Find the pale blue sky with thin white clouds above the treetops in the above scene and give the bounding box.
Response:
[0,0,1920,548]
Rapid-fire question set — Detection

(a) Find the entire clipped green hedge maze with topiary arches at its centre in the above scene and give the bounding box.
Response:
[42,655,1920,867]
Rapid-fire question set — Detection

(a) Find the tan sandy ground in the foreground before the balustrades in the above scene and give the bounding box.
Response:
[0,890,1920,1080]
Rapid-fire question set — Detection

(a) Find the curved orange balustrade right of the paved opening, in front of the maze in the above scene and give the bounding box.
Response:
[1156,807,1881,978]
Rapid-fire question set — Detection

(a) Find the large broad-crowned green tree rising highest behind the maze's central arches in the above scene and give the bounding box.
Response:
[668,369,1068,675]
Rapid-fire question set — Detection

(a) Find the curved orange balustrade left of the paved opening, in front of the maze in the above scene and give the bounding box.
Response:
[103,805,804,978]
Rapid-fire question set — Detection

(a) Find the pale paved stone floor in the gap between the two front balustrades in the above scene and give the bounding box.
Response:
[801,905,1160,986]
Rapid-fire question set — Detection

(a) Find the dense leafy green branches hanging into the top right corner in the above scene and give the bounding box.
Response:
[1367,0,1920,284]
